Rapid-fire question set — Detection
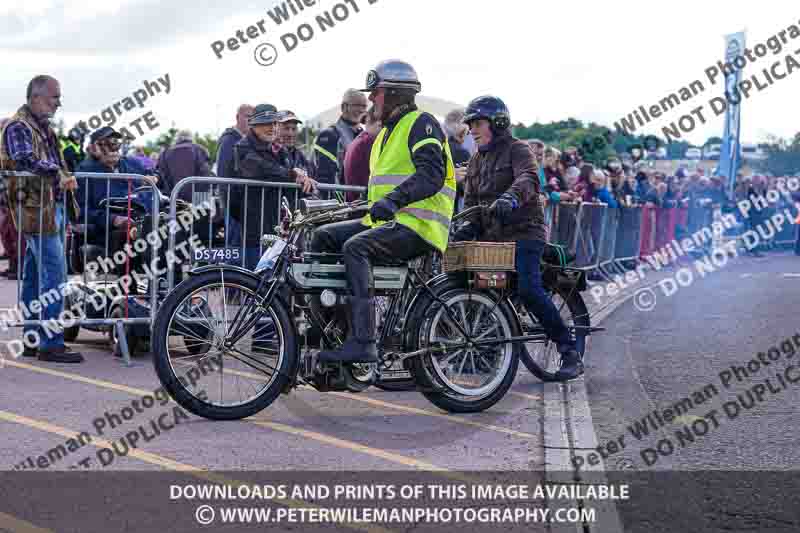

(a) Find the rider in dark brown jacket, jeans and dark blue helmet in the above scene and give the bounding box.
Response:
[455,96,583,381]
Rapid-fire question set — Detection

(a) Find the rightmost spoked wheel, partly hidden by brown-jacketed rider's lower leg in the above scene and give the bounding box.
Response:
[519,289,589,381]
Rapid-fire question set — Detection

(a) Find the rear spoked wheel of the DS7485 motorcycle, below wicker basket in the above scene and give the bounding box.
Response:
[412,289,520,413]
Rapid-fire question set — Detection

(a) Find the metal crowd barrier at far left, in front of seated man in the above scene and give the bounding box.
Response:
[0,171,160,366]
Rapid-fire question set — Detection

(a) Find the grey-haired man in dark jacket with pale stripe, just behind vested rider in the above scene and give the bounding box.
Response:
[314,89,367,184]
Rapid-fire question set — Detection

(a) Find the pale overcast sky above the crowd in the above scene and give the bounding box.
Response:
[0,0,800,143]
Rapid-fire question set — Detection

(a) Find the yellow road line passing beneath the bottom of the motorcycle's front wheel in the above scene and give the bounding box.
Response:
[0,362,446,471]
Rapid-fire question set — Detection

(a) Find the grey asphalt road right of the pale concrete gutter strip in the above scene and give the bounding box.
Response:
[585,250,800,531]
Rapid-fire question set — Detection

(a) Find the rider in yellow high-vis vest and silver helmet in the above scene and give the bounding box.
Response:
[311,60,456,363]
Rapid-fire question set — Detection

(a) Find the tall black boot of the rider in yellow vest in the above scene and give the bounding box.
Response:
[319,297,378,363]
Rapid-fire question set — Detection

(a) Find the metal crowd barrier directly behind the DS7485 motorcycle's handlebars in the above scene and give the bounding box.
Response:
[167,176,366,291]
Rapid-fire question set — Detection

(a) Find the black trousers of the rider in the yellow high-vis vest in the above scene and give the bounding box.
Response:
[311,220,434,298]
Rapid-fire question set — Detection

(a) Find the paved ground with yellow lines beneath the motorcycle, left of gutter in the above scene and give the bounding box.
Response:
[0,268,544,531]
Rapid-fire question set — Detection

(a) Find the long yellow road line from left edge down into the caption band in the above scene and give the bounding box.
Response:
[0,410,388,533]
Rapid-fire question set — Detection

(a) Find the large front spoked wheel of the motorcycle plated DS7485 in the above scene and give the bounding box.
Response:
[153,271,297,420]
